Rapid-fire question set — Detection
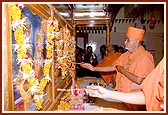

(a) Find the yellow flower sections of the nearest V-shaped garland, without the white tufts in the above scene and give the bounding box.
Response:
[10,4,50,110]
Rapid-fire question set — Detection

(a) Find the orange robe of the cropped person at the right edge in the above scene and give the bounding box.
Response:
[141,58,164,111]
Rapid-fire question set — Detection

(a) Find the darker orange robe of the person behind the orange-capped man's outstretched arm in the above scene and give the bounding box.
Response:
[97,52,121,84]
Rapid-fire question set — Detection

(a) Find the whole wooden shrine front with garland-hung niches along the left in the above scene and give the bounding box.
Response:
[8,4,75,111]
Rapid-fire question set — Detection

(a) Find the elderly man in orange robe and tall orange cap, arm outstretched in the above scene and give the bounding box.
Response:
[81,26,155,110]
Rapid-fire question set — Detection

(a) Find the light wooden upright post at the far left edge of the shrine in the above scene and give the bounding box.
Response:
[2,4,14,111]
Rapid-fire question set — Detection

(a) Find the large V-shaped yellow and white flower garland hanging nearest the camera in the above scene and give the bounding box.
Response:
[10,4,50,110]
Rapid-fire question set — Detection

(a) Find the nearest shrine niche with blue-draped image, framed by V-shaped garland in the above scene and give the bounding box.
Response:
[10,4,51,111]
